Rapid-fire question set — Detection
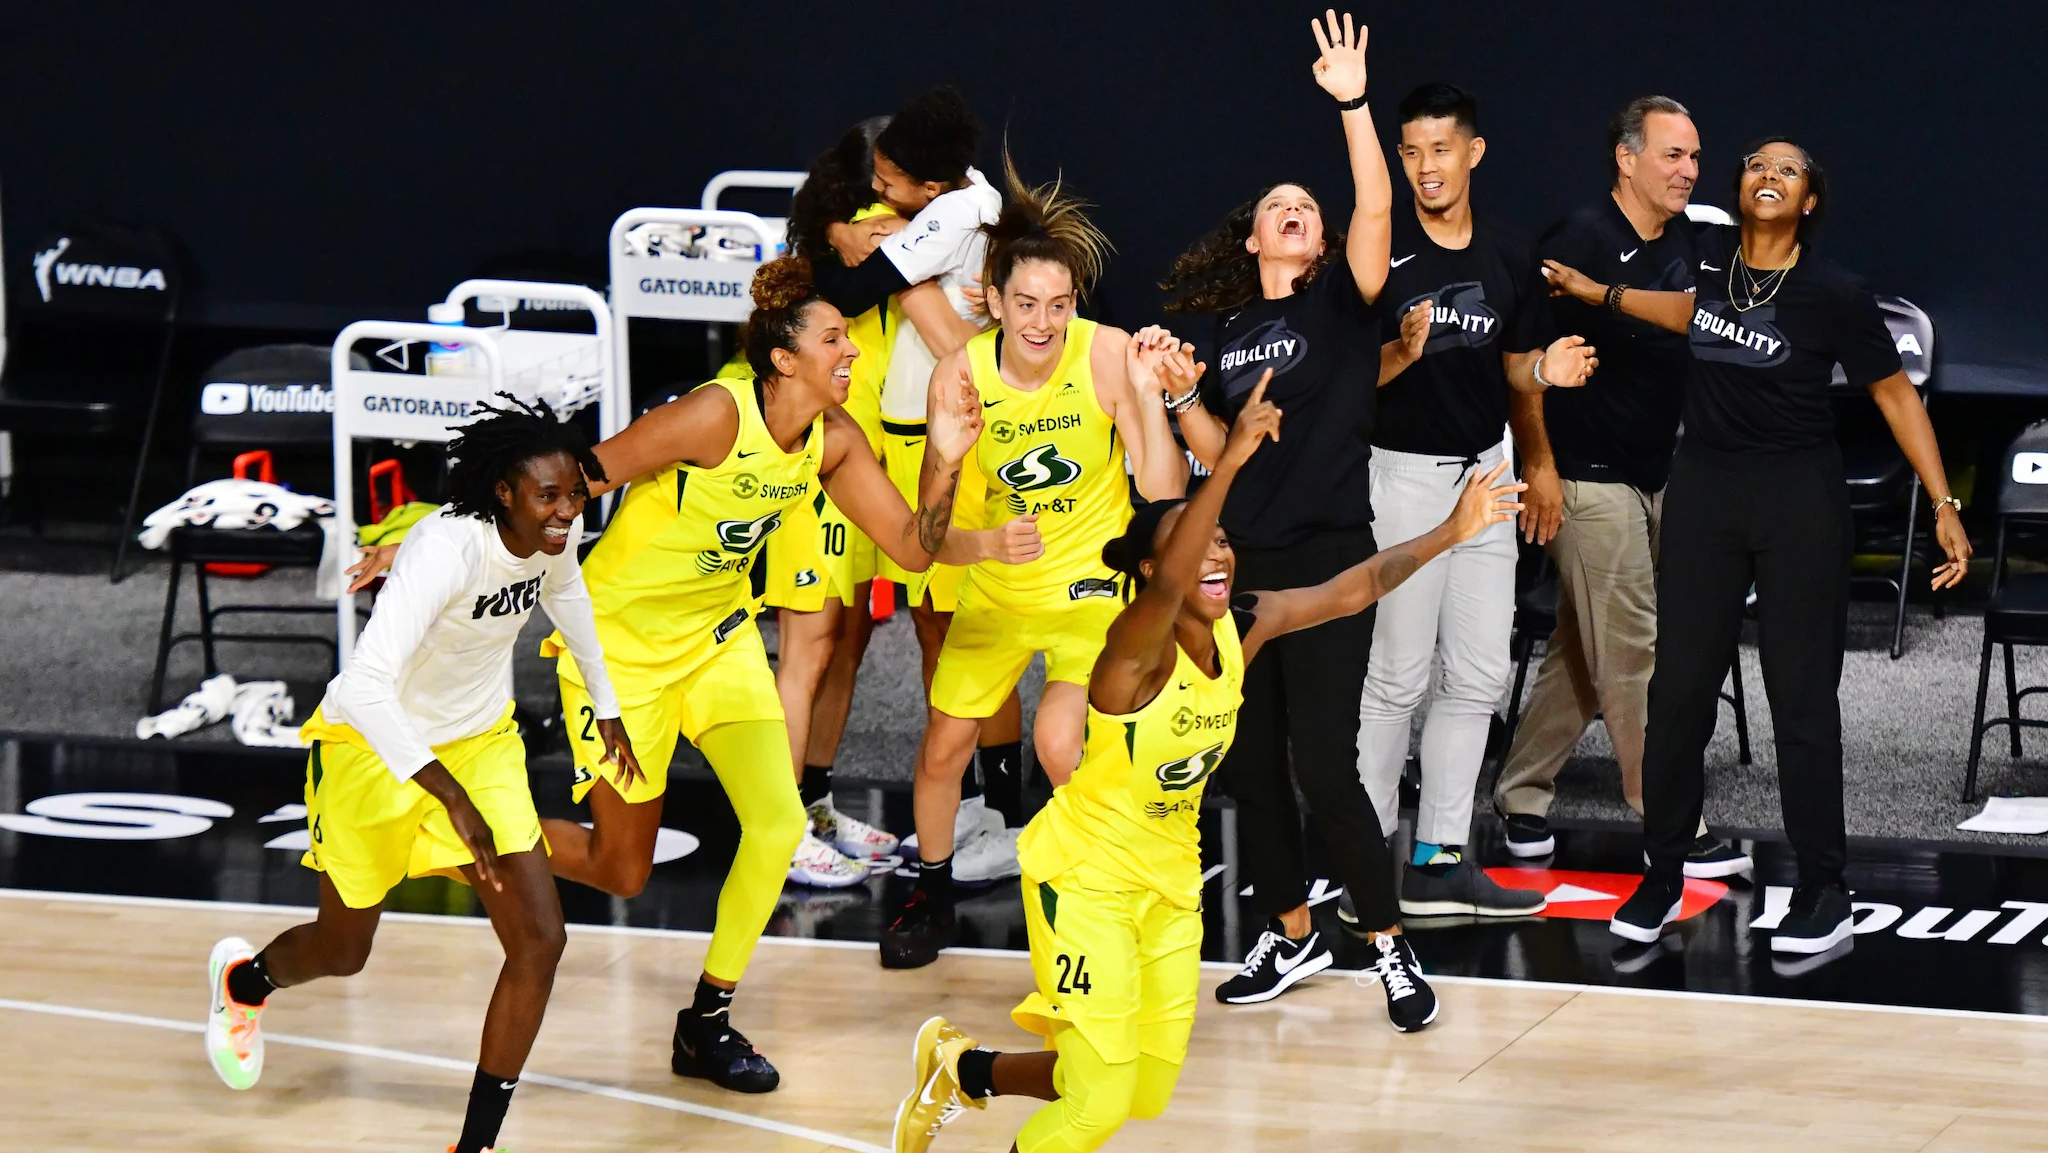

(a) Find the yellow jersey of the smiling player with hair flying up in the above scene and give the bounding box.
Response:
[967,317,1130,612]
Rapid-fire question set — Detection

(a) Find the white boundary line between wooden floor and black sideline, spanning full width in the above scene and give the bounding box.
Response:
[0,889,2048,1032]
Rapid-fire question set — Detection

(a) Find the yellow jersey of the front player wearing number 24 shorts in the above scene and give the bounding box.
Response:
[1018,614,1245,909]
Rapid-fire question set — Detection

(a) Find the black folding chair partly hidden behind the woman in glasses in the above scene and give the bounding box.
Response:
[1833,297,1939,659]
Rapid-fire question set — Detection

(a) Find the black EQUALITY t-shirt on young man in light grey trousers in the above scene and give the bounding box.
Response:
[1372,207,1556,457]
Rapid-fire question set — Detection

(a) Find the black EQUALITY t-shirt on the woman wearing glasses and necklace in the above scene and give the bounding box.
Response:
[1686,225,1898,453]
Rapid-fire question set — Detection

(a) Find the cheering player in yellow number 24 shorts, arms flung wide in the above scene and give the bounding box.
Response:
[895,373,1524,1153]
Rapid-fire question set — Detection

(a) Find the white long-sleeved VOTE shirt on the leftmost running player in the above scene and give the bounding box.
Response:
[319,508,618,780]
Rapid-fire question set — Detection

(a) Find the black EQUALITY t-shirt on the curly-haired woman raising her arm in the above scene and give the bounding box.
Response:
[1200,252,1380,549]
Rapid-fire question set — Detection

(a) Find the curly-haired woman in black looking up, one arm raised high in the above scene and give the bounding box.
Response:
[1163,12,1425,1019]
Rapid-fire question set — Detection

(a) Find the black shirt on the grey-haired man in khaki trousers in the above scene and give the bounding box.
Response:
[1536,195,1700,492]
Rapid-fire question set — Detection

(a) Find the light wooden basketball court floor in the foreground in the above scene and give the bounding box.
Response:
[0,891,2048,1153]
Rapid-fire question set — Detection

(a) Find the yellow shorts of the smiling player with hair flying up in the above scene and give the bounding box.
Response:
[932,580,1124,721]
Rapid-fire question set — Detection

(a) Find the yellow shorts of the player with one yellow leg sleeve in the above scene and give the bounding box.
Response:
[555,612,784,805]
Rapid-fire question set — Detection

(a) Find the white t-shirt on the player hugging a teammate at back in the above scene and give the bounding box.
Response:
[881,168,1004,424]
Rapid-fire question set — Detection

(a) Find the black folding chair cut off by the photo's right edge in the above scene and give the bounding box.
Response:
[1962,420,2048,801]
